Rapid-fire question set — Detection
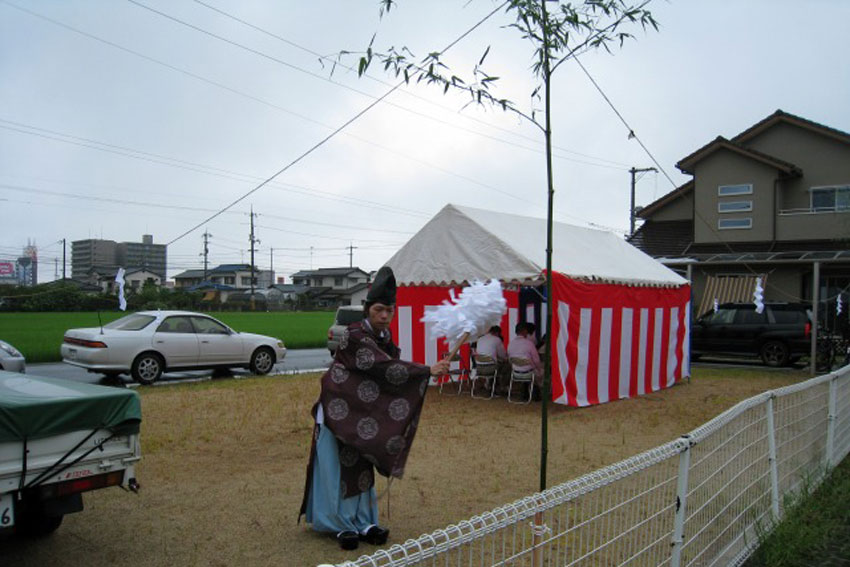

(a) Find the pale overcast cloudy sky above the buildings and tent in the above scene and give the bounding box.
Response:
[0,0,850,282]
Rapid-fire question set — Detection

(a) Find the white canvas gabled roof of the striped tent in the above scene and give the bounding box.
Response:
[387,204,687,287]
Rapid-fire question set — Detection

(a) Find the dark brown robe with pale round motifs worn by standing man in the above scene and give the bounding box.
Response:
[301,321,431,514]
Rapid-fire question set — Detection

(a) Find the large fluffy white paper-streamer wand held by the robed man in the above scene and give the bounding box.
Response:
[422,280,507,348]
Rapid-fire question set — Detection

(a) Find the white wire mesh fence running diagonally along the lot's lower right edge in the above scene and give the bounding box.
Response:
[320,366,850,567]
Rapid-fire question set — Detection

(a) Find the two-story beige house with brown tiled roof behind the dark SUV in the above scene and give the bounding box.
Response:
[630,110,850,328]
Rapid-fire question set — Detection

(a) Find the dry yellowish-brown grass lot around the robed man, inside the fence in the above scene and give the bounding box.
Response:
[0,369,807,567]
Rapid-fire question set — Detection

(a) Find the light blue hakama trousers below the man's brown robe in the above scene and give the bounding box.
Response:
[306,425,378,533]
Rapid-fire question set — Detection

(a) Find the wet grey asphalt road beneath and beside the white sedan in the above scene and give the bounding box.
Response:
[27,348,331,385]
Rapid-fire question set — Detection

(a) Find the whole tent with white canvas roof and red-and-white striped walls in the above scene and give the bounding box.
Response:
[387,205,690,406]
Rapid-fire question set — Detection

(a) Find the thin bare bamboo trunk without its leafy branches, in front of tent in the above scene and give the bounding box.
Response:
[540,0,555,492]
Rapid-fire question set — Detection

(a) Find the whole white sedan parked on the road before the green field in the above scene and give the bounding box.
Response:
[62,311,286,384]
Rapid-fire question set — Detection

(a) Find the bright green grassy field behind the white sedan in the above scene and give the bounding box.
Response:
[0,311,334,362]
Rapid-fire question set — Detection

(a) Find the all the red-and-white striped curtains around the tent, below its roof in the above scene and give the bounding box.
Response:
[392,273,690,406]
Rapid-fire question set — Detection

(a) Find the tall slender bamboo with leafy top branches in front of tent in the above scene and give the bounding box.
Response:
[358,0,658,491]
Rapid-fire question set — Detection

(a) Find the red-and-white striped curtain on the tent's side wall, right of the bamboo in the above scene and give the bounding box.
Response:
[552,273,690,406]
